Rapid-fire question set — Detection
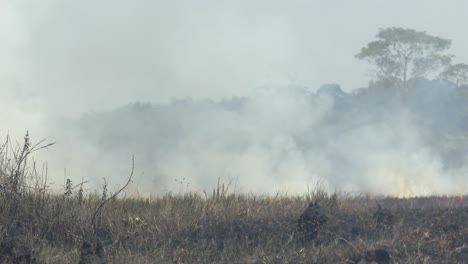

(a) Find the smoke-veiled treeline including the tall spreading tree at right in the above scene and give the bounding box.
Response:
[68,28,468,192]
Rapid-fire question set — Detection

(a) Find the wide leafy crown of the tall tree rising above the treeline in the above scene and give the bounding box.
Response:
[356,27,452,85]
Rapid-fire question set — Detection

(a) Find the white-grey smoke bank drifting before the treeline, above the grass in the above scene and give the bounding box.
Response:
[37,80,468,196]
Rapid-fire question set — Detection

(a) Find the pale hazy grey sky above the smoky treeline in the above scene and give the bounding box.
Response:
[0,0,468,115]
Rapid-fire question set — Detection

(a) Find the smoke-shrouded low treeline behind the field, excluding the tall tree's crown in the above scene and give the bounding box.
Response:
[75,79,468,192]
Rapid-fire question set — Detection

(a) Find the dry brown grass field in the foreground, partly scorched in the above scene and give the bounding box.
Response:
[0,134,468,263]
